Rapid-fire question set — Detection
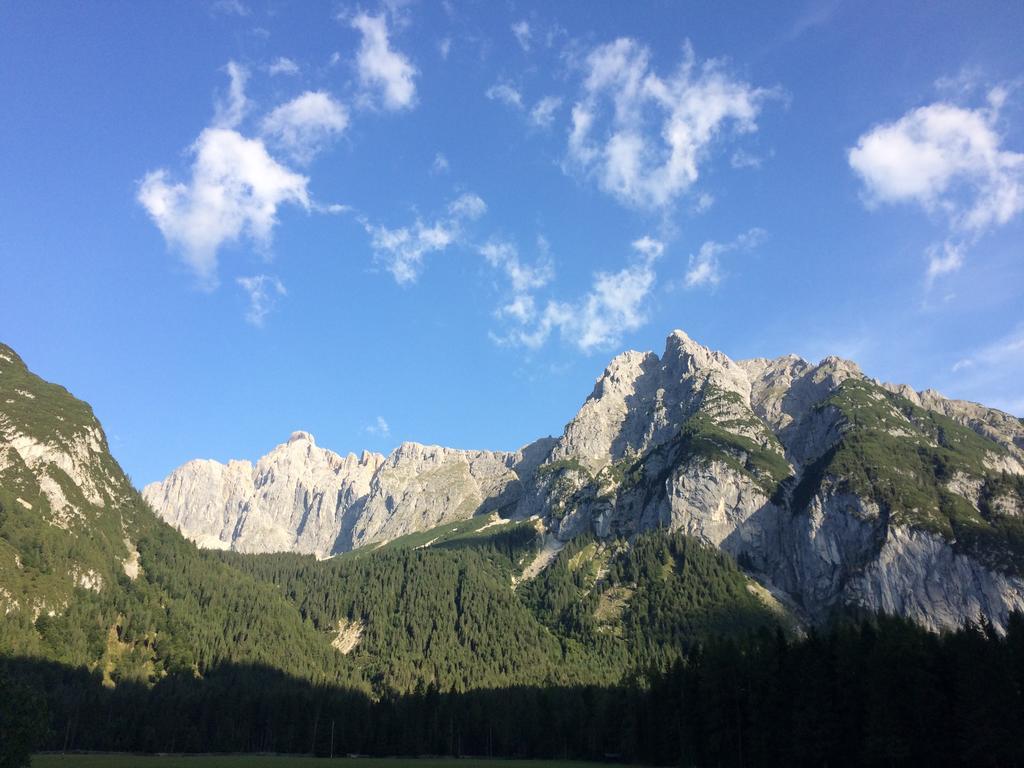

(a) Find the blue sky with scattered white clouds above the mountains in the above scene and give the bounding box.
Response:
[0,0,1024,484]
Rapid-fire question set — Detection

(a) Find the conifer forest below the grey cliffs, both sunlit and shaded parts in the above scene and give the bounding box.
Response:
[6,525,1024,766]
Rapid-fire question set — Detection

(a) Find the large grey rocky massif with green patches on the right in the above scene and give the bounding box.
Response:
[536,332,1024,628]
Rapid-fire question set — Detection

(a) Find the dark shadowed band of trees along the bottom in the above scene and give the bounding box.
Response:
[8,615,1024,766]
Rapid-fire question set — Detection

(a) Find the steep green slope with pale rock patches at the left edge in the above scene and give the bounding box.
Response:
[0,346,366,685]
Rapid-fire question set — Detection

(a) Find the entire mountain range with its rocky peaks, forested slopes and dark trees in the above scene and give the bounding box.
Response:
[6,331,1024,766]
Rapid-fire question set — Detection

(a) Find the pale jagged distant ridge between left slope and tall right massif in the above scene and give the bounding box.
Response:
[142,432,546,557]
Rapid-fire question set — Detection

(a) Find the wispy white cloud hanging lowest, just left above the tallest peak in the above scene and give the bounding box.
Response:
[495,237,665,352]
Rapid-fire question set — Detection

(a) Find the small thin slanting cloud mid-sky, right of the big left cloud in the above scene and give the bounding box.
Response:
[362,193,487,285]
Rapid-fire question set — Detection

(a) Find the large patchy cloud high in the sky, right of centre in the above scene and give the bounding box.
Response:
[568,38,771,209]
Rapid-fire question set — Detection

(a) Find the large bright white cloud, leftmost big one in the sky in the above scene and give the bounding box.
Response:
[138,128,310,287]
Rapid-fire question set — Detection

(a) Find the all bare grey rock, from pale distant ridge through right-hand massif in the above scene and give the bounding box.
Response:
[143,331,1024,628]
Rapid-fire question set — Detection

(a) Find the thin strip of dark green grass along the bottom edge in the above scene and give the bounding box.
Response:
[32,755,595,768]
